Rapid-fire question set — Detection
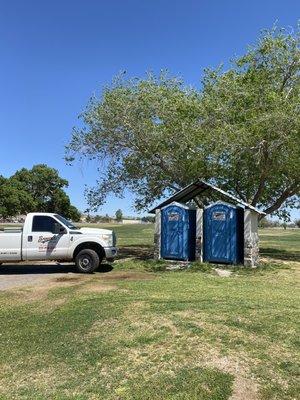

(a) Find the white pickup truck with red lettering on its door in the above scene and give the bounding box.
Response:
[0,213,117,273]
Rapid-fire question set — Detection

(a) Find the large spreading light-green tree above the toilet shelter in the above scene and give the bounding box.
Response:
[67,23,300,218]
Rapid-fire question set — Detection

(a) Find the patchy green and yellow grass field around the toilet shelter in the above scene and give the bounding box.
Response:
[0,225,300,400]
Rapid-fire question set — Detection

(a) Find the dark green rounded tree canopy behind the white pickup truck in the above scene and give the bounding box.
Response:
[0,164,80,221]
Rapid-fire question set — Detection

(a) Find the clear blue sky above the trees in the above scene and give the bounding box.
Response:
[0,0,300,216]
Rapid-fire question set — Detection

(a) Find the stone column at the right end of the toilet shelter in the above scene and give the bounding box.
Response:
[244,210,259,267]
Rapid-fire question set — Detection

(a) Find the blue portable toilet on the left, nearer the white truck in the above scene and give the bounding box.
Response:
[161,202,196,261]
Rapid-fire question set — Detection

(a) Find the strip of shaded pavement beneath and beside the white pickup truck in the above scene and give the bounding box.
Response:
[0,262,112,291]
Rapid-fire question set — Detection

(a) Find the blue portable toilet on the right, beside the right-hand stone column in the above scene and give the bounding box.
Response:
[203,202,244,264]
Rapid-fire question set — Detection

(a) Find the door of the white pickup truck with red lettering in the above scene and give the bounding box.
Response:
[23,215,70,261]
